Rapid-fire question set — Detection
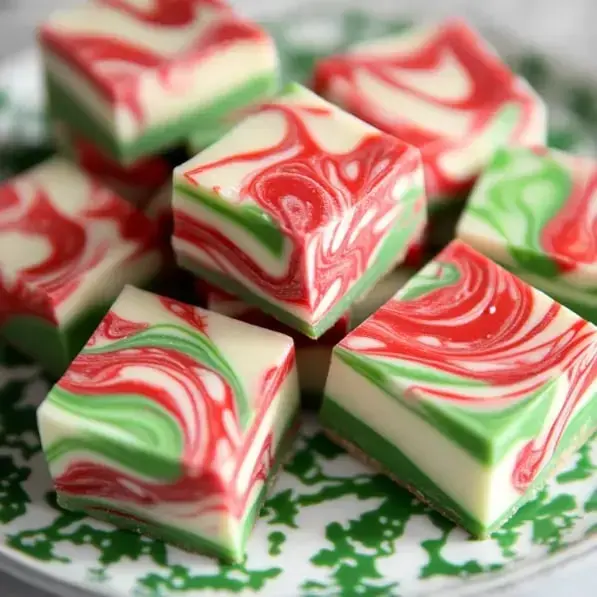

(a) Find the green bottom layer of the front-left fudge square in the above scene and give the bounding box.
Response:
[57,413,299,563]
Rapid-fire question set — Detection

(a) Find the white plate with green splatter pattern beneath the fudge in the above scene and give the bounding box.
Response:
[0,5,597,597]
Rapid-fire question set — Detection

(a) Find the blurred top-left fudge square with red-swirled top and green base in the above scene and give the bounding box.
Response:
[39,0,278,164]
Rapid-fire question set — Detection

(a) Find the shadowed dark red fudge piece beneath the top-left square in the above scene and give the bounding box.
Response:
[52,123,172,209]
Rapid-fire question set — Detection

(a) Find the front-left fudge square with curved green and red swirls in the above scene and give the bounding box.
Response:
[38,286,299,561]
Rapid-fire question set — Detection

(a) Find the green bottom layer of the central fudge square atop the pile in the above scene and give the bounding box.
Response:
[177,212,419,339]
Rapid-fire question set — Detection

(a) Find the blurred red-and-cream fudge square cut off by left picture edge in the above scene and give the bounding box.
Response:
[0,155,164,376]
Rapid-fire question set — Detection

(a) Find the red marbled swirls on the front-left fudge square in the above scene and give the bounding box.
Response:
[55,304,294,518]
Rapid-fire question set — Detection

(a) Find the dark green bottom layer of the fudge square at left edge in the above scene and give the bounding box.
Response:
[0,302,111,379]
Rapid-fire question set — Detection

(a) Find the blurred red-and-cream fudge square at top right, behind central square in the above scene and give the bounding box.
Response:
[314,20,547,209]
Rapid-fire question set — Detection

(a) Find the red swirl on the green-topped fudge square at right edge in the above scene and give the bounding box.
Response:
[540,158,597,273]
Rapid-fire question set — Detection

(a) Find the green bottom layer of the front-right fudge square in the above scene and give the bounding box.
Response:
[320,396,597,538]
